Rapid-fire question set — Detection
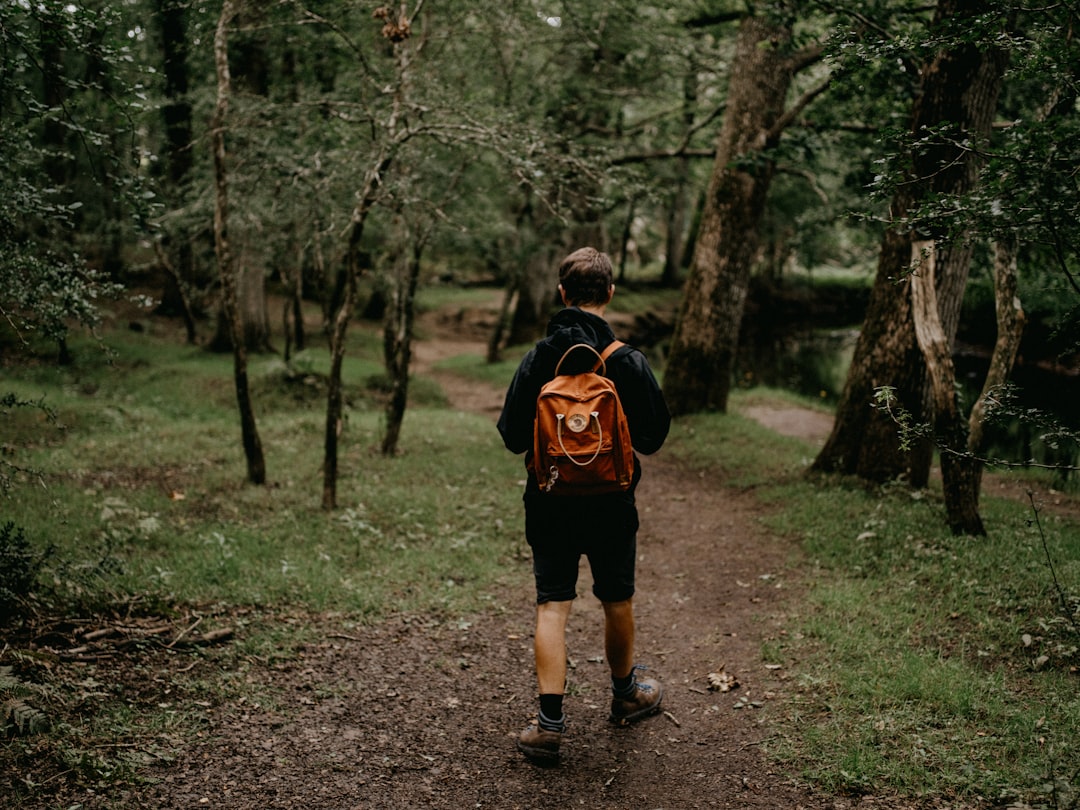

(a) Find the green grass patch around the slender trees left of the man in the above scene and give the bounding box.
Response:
[4,326,521,618]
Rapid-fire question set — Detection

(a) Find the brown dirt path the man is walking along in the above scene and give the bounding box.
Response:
[14,306,1062,810]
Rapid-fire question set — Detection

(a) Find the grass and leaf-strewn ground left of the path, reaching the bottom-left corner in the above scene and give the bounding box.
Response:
[0,315,530,802]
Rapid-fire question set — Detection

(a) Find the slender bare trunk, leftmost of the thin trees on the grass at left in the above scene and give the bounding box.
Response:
[211,0,266,484]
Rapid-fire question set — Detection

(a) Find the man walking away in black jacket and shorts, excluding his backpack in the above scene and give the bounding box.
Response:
[498,247,671,764]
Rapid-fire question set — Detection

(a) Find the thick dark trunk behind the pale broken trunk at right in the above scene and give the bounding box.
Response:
[812,0,1004,487]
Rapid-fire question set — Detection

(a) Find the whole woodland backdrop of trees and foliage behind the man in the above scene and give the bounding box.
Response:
[0,0,1080,804]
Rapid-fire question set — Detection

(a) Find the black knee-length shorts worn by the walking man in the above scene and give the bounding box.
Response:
[524,487,638,605]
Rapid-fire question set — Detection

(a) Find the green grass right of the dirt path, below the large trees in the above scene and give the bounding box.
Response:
[669,401,1080,808]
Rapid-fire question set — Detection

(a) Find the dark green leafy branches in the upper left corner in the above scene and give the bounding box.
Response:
[0,0,137,346]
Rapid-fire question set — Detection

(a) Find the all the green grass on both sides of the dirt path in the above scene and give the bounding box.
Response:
[0,313,1080,808]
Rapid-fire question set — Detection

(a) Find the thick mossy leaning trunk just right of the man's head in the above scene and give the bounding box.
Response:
[664,16,793,414]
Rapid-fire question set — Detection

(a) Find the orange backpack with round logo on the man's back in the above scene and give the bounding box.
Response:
[532,340,634,495]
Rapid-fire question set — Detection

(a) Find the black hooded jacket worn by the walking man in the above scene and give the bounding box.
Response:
[498,307,671,480]
